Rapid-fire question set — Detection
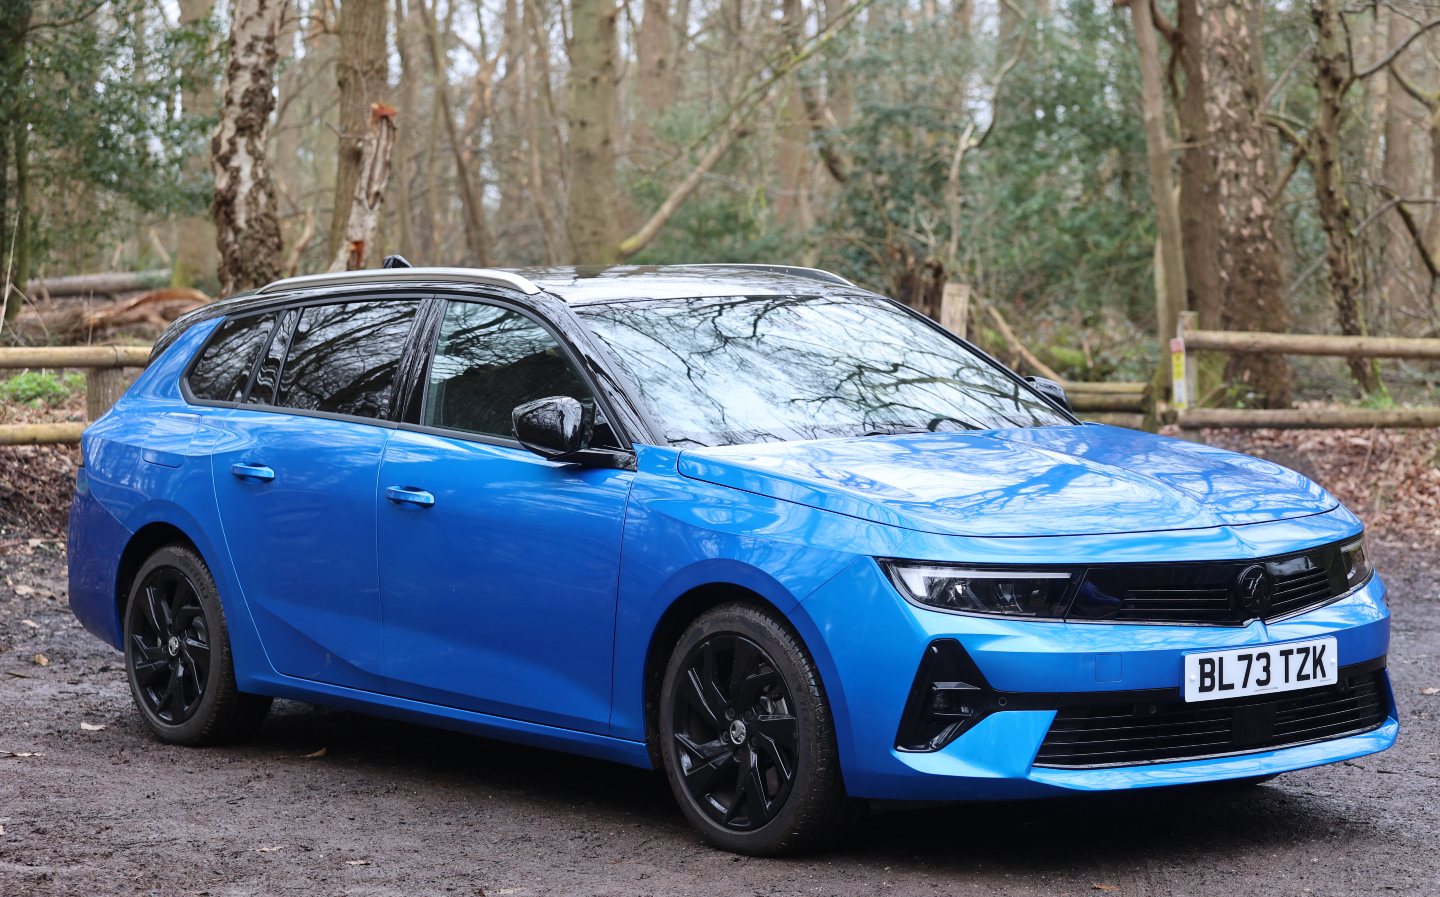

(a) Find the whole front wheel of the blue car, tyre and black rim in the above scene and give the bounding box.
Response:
[660,603,863,857]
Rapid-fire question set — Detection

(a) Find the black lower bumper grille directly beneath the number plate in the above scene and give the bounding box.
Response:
[1035,658,1388,767]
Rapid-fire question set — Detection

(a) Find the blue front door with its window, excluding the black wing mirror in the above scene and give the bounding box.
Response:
[379,301,632,733]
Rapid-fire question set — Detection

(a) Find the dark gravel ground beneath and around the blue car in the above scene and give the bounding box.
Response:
[0,543,1440,897]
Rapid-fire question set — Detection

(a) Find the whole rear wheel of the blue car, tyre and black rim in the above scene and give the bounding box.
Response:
[125,546,271,744]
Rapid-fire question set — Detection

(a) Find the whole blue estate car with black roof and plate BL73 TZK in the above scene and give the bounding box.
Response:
[69,265,1398,854]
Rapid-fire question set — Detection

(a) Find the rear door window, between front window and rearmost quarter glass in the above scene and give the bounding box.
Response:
[275,299,419,420]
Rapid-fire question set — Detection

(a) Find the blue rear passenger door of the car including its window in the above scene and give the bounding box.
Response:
[212,294,425,691]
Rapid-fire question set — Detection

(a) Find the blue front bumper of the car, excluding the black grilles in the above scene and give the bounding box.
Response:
[796,559,1398,801]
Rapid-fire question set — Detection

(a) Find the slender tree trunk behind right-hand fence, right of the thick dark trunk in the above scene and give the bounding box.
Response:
[1310,0,1384,395]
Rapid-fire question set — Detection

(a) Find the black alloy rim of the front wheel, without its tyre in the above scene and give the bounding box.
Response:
[674,634,799,832]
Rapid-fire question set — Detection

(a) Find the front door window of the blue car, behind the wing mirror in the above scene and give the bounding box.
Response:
[425,302,596,445]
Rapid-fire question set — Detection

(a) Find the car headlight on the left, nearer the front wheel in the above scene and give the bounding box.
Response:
[881,560,1073,619]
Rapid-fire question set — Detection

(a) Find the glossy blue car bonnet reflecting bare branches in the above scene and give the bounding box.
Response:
[678,425,1339,537]
